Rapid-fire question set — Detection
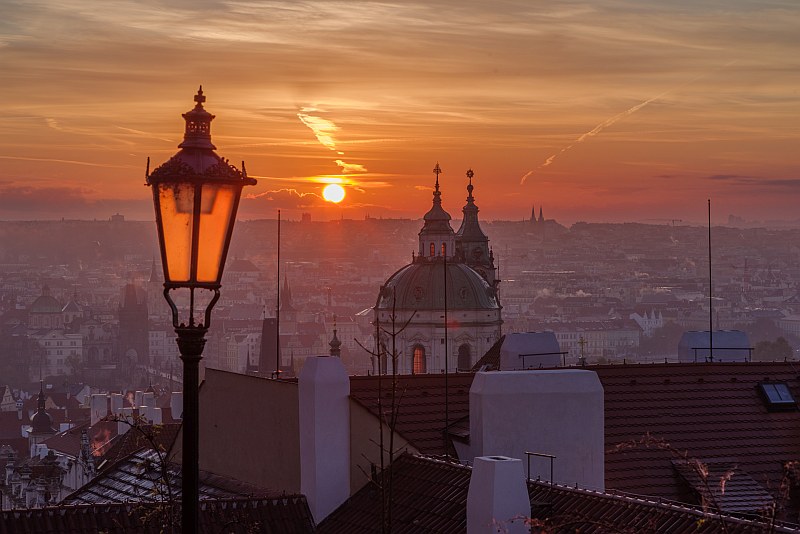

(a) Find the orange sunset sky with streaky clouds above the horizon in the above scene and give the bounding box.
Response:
[0,0,800,223]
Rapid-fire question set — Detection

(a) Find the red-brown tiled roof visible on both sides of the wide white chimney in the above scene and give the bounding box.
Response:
[350,362,800,520]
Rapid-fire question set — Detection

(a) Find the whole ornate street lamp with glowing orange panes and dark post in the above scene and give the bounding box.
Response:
[146,86,256,533]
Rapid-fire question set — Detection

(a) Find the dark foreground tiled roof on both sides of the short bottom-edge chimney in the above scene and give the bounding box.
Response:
[317,454,798,534]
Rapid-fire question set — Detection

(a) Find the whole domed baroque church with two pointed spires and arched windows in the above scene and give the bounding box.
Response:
[373,168,503,374]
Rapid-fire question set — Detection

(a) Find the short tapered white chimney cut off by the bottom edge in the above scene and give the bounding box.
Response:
[467,456,531,534]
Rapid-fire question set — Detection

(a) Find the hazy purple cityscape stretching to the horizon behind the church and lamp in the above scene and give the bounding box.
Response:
[0,213,800,388]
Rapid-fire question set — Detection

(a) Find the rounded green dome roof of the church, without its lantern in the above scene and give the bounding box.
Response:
[376,258,500,311]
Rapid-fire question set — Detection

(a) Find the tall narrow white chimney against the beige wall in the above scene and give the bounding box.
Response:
[298,356,350,523]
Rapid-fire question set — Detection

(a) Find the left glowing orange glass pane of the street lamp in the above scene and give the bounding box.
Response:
[158,182,194,282]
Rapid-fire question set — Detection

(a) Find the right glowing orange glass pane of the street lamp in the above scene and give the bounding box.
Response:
[197,183,236,283]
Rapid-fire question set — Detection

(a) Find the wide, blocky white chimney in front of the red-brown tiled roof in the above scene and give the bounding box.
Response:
[469,369,605,491]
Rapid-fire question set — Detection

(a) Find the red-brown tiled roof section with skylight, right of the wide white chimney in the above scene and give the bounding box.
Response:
[593,362,800,512]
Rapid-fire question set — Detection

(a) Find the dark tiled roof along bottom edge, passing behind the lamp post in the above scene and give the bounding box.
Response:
[0,495,314,534]
